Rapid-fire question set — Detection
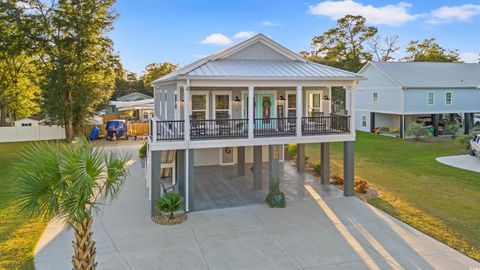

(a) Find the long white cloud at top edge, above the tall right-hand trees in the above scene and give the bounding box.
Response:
[309,0,420,26]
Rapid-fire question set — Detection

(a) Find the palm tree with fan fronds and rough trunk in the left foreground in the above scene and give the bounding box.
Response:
[13,139,128,270]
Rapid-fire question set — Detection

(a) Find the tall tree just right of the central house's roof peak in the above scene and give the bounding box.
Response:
[302,15,378,72]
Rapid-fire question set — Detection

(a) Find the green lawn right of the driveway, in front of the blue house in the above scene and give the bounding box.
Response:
[306,132,480,260]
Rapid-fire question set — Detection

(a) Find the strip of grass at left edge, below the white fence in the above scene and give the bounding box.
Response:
[0,143,48,269]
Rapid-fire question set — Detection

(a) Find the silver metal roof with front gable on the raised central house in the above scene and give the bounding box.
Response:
[152,34,363,84]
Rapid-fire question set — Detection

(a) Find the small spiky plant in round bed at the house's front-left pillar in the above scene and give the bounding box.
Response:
[154,191,187,225]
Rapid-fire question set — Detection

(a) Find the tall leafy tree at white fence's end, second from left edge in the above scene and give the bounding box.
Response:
[30,0,118,140]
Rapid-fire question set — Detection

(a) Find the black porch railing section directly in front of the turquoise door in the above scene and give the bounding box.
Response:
[253,117,297,137]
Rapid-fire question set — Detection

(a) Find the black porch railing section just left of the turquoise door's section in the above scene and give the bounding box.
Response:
[190,119,248,140]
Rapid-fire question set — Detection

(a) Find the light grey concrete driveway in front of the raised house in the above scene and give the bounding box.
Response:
[35,147,480,270]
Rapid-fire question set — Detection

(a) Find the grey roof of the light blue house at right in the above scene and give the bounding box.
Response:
[359,62,480,88]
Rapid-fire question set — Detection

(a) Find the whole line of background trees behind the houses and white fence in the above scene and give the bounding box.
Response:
[0,0,472,140]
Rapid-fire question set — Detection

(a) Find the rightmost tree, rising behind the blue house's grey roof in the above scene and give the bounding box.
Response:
[404,38,461,63]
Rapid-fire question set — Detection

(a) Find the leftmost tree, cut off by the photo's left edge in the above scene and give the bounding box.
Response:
[0,0,41,126]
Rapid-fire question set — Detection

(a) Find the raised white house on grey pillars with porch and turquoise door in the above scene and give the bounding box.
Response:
[146,34,363,215]
